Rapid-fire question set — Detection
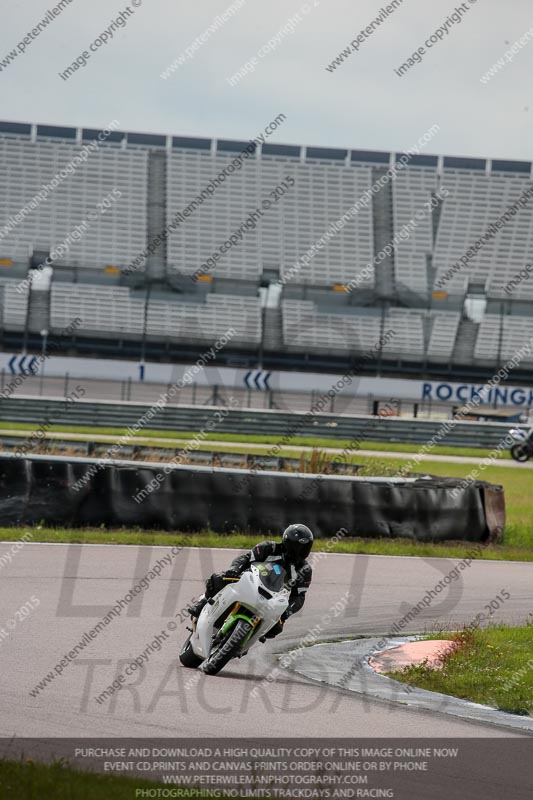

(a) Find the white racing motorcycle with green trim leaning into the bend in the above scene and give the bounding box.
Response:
[179,562,290,675]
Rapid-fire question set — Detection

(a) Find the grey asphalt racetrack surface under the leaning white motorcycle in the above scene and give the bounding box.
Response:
[0,542,533,737]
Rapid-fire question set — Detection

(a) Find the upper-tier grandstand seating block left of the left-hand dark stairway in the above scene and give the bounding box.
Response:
[0,136,147,269]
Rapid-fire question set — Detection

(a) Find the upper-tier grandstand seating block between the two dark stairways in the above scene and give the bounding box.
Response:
[167,150,373,285]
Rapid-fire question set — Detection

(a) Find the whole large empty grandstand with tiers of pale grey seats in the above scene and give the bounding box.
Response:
[0,122,533,378]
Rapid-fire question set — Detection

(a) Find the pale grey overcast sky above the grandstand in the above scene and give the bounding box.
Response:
[0,0,533,160]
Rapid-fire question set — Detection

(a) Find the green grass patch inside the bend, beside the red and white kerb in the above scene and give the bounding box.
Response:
[388,618,533,716]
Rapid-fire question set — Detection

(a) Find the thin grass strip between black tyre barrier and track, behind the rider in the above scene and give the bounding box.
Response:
[0,525,533,561]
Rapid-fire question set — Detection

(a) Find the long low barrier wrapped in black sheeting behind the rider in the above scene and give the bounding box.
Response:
[0,454,505,542]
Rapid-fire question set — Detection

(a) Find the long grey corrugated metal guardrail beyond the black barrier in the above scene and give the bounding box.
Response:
[0,397,513,448]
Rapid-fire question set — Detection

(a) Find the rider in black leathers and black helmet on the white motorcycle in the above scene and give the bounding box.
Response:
[188,522,313,639]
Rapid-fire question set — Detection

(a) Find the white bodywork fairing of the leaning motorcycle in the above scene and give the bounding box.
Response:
[190,563,290,659]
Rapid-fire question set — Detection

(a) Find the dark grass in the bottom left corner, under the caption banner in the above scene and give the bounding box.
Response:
[0,759,236,800]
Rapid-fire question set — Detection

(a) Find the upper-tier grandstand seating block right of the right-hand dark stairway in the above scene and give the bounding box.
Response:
[393,166,533,300]
